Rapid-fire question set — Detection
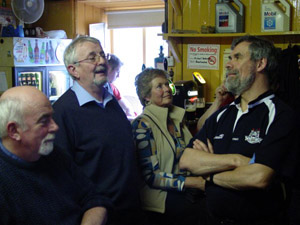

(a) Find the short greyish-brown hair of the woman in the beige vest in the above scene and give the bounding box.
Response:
[135,68,168,106]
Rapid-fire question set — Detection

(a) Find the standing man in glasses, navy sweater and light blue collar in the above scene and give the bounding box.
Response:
[53,36,141,225]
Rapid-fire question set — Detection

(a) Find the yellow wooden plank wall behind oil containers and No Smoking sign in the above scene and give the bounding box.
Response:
[164,0,300,102]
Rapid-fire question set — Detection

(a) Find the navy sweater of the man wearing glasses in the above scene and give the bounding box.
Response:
[53,89,139,211]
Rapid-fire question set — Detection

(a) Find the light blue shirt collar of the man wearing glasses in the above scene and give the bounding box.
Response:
[71,81,112,108]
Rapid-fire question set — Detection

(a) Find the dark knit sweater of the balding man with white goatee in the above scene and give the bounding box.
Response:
[0,145,110,225]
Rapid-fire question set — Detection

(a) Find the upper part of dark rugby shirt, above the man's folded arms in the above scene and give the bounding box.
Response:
[188,91,295,175]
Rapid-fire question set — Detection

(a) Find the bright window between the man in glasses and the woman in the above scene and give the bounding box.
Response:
[111,26,168,114]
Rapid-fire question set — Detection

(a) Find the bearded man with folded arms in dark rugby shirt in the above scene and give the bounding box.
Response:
[180,36,297,225]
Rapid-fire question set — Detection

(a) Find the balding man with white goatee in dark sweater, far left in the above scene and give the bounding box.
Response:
[0,86,111,225]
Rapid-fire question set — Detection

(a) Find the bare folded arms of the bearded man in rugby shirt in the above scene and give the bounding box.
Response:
[180,140,275,190]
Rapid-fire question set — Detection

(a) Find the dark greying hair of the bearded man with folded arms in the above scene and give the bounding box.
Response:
[231,35,279,86]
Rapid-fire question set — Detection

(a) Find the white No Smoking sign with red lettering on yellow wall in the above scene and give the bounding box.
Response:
[187,44,220,70]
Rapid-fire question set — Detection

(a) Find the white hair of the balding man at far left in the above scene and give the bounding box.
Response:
[0,97,26,138]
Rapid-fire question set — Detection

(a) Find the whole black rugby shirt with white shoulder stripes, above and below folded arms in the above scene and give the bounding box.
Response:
[188,92,297,221]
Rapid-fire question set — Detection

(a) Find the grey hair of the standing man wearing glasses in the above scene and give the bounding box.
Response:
[64,36,101,79]
